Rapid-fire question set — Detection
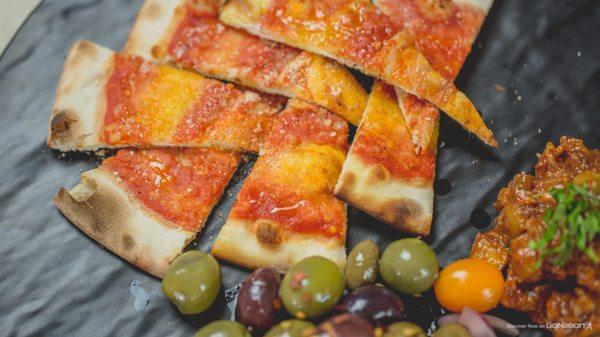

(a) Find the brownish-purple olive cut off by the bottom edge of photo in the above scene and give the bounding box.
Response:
[314,314,375,337]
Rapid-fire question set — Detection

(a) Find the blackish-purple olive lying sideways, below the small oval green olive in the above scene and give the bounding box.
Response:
[341,286,404,325]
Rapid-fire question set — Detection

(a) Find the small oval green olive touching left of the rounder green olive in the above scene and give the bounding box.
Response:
[344,240,379,290]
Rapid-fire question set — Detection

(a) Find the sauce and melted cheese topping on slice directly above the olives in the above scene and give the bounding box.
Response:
[231,100,348,240]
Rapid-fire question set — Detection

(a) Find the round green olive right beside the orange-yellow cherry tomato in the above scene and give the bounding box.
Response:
[379,238,439,295]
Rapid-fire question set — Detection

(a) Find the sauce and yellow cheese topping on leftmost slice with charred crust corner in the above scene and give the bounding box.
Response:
[102,54,285,152]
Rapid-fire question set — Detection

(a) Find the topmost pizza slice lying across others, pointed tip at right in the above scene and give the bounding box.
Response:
[219,0,497,146]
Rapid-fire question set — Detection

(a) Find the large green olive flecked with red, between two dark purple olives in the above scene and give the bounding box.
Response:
[279,256,344,318]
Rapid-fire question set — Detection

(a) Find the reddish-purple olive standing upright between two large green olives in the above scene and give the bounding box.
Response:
[235,268,281,330]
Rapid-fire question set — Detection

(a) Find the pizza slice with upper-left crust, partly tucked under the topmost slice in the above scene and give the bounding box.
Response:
[125,0,367,125]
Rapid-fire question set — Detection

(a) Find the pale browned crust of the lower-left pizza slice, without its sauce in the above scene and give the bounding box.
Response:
[54,168,196,277]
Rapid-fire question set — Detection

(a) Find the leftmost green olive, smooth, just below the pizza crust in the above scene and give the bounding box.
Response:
[162,250,221,315]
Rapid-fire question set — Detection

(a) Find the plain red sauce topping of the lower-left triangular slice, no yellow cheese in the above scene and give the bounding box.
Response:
[101,148,239,232]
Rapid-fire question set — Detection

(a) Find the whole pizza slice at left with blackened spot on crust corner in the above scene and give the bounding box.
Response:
[48,41,285,152]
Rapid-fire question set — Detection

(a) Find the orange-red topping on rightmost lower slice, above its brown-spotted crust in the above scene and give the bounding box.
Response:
[353,84,437,181]
